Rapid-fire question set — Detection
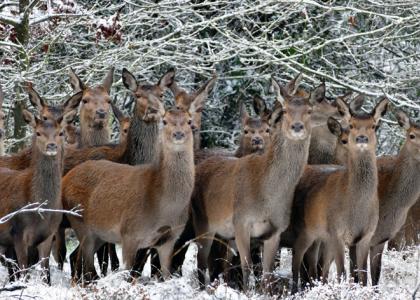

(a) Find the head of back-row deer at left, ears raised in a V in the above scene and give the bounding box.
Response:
[69,67,114,128]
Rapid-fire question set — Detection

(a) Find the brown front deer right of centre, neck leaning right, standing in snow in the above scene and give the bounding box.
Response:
[192,75,312,287]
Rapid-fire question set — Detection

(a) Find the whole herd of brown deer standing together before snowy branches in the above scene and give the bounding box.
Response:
[0,68,420,292]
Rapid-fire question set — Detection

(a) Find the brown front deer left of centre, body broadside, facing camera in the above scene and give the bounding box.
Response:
[63,106,195,279]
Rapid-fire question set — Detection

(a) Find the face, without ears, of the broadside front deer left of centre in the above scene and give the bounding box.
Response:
[162,109,193,151]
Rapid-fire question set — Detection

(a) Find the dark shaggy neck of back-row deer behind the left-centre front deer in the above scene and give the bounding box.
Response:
[124,115,159,166]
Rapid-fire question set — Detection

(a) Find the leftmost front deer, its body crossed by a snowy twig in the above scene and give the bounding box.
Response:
[0,101,82,283]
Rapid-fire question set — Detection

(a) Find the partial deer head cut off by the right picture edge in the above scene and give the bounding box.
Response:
[397,111,420,161]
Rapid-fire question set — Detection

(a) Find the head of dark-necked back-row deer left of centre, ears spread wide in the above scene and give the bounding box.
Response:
[122,68,175,122]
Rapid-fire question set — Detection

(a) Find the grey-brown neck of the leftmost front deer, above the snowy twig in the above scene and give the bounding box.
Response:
[31,141,64,207]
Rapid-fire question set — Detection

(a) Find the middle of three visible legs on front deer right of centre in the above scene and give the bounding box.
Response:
[235,222,252,290]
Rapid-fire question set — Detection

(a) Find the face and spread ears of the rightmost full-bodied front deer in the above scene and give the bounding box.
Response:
[337,98,389,152]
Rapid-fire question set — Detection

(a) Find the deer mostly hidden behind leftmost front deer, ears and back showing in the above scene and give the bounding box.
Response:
[0,82,81,170]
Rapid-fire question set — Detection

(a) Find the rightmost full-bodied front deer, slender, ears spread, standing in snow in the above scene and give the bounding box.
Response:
[292,99,388,292]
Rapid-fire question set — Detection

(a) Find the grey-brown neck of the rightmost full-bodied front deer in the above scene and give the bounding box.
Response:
[347,146,378,202]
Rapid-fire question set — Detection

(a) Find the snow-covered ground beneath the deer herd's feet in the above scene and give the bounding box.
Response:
[0,244,420,300]
